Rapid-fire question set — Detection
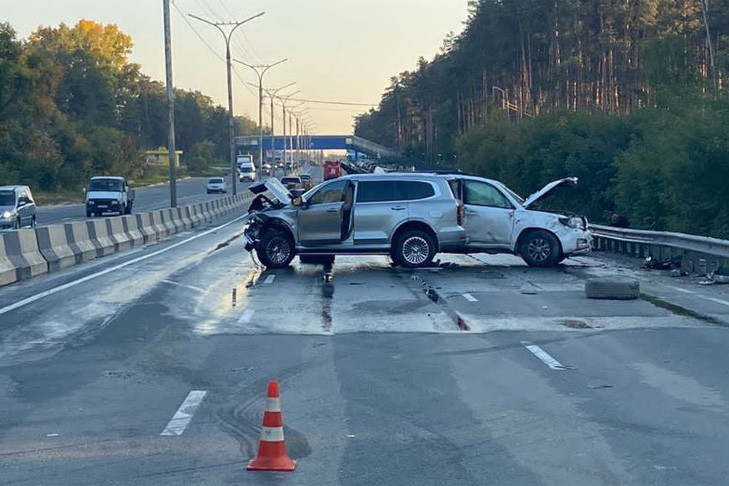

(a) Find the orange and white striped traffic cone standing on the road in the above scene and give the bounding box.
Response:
[248,381,296,471]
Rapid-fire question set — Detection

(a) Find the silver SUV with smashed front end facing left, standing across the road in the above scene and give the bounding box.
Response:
[244,174,466,268]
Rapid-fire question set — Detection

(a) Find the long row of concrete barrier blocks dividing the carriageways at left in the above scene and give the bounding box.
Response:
[0,191,254,287]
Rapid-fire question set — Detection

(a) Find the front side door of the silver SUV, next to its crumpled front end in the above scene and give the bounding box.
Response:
[298,180,349,246]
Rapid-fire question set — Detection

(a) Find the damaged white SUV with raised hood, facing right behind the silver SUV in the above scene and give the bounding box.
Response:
[445,174,590,267]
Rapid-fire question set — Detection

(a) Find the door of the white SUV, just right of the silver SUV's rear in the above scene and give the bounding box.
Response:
[459,179,514,248]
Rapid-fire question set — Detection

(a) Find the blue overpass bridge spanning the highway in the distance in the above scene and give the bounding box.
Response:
[235,135,401,159]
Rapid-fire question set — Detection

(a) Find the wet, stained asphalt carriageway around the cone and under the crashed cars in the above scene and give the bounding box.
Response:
[0,166,729,485]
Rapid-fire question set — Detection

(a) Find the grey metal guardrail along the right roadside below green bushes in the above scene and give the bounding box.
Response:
[590,225,729,274]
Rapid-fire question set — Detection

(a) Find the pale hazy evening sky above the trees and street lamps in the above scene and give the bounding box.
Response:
[0,0,467,133]
